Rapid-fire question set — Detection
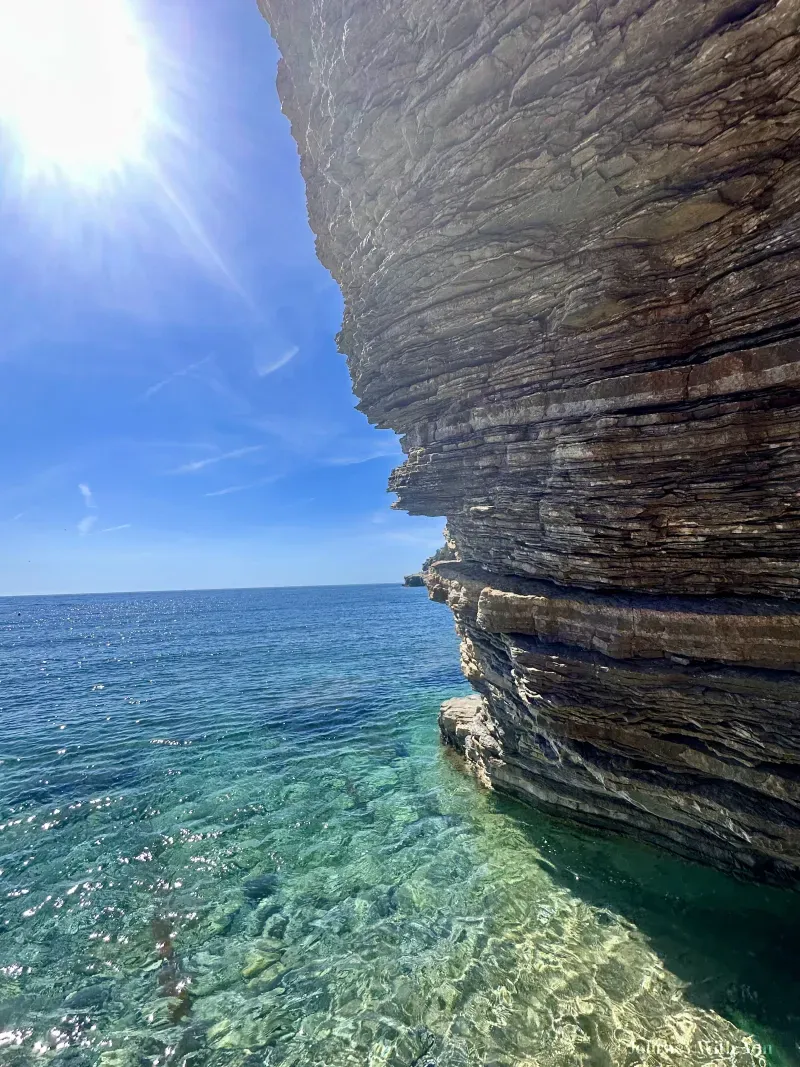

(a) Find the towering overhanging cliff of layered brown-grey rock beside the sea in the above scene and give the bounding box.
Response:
[260,0,800,879]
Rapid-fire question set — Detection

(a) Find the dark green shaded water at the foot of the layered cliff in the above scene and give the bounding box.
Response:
[492,794,800,1067]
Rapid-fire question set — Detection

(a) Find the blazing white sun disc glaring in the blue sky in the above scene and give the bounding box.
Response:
[0,0,155,184]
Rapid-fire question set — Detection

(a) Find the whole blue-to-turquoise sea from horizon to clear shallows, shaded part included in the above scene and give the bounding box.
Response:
[0,586,800,1067]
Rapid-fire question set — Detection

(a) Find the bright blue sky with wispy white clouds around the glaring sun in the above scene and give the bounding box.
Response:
[0,0,444,594]
